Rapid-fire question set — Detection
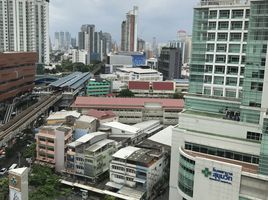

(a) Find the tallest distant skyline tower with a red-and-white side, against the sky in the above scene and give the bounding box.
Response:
[121,6,138,51]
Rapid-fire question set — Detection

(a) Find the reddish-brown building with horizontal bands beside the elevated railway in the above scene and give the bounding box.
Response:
[0,52,37,102]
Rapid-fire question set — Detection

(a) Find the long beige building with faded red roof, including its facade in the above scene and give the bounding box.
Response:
[72,97,184,125]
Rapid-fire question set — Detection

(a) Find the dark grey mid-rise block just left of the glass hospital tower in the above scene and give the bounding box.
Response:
[158,47,182,80]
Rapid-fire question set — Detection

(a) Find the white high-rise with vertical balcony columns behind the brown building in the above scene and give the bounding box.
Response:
[0,0,50,63]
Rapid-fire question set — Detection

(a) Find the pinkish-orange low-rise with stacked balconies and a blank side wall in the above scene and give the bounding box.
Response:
[35,126,73,172]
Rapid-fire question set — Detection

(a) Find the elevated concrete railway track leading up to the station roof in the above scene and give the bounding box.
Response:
[0,92,62,147]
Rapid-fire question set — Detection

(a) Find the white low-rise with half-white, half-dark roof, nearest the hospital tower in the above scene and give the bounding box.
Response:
[108,146,167,198]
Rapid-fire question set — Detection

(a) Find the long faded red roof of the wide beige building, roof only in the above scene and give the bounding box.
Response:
[72,97,184,110]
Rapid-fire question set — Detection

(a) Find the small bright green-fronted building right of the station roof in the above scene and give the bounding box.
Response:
[87,80,111,96]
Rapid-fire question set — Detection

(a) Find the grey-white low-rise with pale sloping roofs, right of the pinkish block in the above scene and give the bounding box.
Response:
[66,132,116,181]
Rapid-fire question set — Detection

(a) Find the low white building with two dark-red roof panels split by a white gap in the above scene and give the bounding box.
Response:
[128,81,176,98]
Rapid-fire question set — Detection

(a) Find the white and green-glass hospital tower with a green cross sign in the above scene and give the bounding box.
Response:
[169,0,268,200]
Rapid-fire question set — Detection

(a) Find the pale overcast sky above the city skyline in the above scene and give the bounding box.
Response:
[50,0,198,43]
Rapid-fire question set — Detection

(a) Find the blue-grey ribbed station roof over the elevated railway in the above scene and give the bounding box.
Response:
[50,72,90,89]
